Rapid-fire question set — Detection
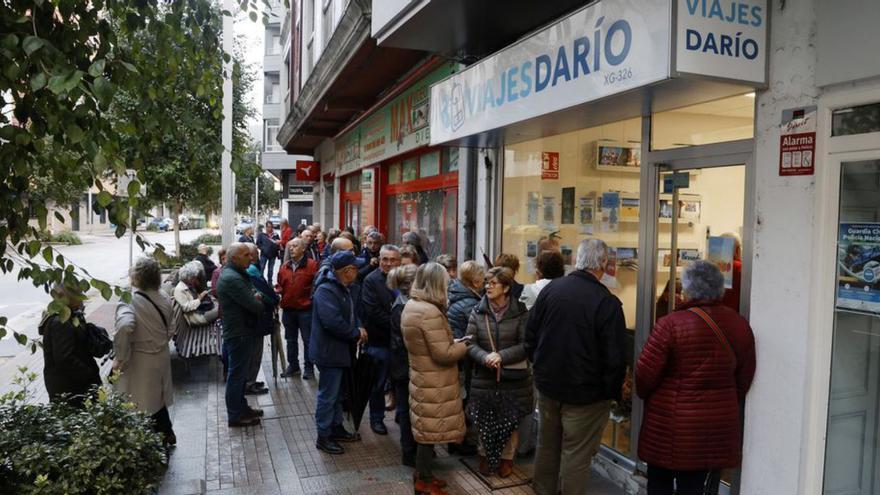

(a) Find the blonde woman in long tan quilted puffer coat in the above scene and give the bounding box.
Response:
[401,262,467,495]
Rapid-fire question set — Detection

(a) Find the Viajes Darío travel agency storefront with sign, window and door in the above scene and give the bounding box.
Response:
[431,0,770,490]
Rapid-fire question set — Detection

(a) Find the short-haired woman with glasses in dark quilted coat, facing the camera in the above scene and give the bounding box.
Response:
[467,267,534,478]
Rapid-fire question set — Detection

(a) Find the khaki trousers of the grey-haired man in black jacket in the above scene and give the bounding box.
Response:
[532,394,611,495]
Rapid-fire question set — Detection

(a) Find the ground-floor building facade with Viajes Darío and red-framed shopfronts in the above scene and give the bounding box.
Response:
[279,0,880,495]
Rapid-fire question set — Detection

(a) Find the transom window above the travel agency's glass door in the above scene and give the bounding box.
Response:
[651,93,755,150]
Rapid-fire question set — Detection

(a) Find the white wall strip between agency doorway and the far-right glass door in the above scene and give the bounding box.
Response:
[740,0,822,495]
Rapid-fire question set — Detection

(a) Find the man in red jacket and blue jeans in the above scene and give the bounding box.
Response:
[275,236,318,380]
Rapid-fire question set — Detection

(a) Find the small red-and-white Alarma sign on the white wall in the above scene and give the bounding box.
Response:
[779,106,816,177]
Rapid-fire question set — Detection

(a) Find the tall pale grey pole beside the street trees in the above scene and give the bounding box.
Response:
[220,0,236,247]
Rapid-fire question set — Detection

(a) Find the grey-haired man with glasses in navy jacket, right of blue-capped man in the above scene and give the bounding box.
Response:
[360,246,400,435]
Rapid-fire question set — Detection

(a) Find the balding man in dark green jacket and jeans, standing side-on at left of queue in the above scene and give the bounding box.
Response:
[217,242,263,427]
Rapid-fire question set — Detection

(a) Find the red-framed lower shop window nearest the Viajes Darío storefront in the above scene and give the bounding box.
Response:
[388,189,458,259]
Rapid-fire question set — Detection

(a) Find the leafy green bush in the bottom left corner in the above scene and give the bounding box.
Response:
[0,378,167,494]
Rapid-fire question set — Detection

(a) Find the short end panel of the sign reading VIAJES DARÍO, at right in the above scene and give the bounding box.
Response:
[674,0,770,85]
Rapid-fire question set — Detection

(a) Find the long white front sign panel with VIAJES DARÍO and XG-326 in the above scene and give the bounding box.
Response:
[431,0,672,145]
